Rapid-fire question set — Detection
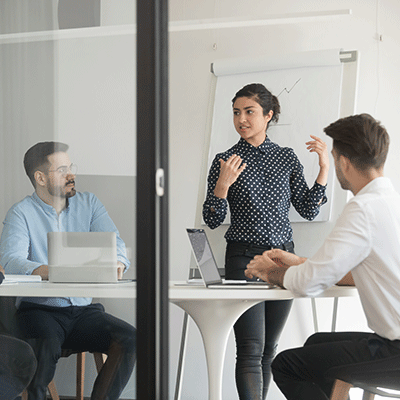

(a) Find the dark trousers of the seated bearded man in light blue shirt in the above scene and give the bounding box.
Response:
[17,302,136,400]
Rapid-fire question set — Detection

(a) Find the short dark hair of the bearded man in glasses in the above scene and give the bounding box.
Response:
[24,142,69,188]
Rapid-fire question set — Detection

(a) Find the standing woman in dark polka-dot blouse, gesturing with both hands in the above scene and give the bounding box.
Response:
[203,83,329,400]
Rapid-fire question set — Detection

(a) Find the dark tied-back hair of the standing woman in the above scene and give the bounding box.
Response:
[232,83,281,124]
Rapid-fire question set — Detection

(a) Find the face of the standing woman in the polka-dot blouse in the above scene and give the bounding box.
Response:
[233,97,273,147]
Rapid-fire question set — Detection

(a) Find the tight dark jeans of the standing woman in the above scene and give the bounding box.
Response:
[225,243,293,400]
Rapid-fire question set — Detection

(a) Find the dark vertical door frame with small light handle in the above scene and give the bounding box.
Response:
[136,0,169,400]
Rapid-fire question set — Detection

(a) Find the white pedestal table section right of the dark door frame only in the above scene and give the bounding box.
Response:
[169,282,357,400]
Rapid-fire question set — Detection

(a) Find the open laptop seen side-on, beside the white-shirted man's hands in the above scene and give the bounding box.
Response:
[186,228,275,289]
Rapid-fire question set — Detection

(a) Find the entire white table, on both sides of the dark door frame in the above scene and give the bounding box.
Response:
[0,281,357,400]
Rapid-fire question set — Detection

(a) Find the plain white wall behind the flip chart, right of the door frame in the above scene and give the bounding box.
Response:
[170,0,400,400]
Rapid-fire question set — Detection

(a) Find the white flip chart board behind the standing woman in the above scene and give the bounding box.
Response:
[207,50,342,223]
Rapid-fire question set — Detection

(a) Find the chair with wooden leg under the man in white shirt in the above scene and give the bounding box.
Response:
[327,355,400,400]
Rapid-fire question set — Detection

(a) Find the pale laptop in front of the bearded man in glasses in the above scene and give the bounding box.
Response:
[47,232,118,283]
